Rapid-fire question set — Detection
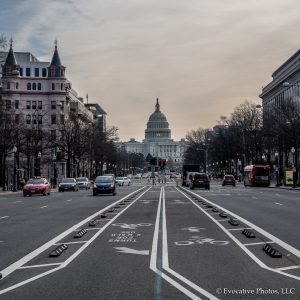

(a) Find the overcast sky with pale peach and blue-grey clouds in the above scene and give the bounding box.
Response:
[0,0,300,141]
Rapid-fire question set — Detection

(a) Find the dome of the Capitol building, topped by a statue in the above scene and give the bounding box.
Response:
[145,98,171,141]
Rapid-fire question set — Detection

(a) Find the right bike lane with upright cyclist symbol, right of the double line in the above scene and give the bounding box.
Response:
[162,188,300,299]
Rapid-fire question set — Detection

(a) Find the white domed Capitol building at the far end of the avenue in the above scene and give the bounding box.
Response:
[123,98,186,165]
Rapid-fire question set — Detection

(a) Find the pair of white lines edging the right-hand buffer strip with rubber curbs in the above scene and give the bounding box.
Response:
[176,188,300,280]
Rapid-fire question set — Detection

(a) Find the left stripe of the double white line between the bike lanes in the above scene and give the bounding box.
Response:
[150,188,201,300]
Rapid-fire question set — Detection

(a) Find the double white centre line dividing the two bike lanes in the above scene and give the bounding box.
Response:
[150,187,218,300]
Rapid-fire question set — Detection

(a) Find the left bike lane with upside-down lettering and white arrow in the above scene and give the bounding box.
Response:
[0,187,191,300]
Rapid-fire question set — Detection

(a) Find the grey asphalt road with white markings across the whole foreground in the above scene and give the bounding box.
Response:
[0,181,300,300]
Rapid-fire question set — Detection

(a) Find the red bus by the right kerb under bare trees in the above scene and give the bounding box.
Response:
[244,165,271,186]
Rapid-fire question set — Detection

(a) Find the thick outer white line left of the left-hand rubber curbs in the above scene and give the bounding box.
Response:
[0,187,148,280]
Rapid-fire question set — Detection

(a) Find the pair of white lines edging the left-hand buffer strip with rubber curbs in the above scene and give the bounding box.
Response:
[0,187,151,295]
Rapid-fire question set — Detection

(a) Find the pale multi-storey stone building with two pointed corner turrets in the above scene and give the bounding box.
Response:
[0,41,106,186]
